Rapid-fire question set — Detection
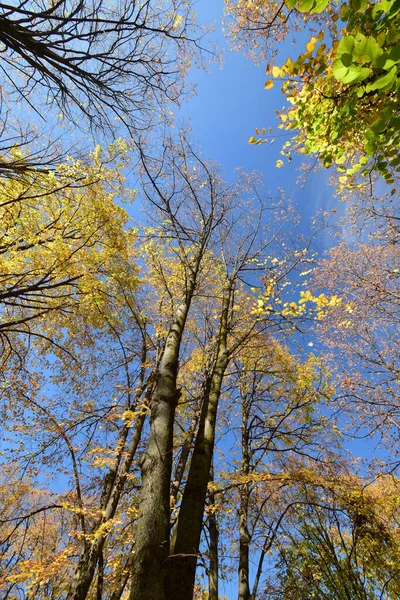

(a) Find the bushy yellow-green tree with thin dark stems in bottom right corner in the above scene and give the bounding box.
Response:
[274,476,400,600]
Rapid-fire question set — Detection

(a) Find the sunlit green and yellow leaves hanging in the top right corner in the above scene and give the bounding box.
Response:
[256,0,400,188]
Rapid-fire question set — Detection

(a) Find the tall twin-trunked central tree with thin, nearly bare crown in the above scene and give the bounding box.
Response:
[131,139,316,599]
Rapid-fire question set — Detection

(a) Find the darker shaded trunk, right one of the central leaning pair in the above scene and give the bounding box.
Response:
[168,283,233,600]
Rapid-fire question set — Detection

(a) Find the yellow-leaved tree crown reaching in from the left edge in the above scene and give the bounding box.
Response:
[0,144,131,364]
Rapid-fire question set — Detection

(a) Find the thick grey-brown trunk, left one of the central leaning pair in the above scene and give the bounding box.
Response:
[130,272,200,600]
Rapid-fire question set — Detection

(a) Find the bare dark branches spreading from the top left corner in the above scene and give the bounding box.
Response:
[0,0,205,129]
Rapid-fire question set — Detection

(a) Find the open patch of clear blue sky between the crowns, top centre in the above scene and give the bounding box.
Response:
[178,0,340,251]
